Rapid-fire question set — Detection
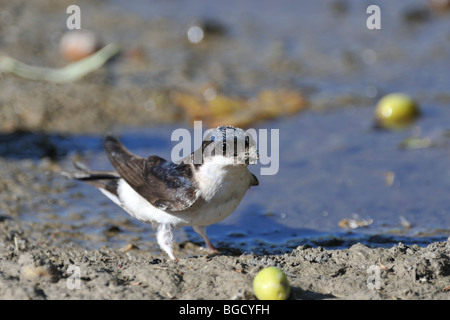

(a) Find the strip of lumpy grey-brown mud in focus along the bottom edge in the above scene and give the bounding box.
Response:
[0,212,450,300]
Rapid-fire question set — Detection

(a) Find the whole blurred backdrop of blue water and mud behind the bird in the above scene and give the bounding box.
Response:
[0,0,450,253]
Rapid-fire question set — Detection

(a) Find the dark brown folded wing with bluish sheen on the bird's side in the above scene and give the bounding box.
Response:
[105,136,198,211]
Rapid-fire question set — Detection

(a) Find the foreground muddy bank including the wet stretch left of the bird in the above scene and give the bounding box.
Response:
[0,152,450,300]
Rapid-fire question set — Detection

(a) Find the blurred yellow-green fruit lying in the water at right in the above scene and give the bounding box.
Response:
[375,93,420,128]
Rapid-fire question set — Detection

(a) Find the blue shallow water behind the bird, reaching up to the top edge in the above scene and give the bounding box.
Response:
[0,0,450,253]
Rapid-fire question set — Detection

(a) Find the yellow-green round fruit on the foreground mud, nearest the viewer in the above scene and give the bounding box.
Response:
[253,267,291,300]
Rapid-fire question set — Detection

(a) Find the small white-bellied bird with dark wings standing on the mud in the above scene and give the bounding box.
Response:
[62,126,259,261]
